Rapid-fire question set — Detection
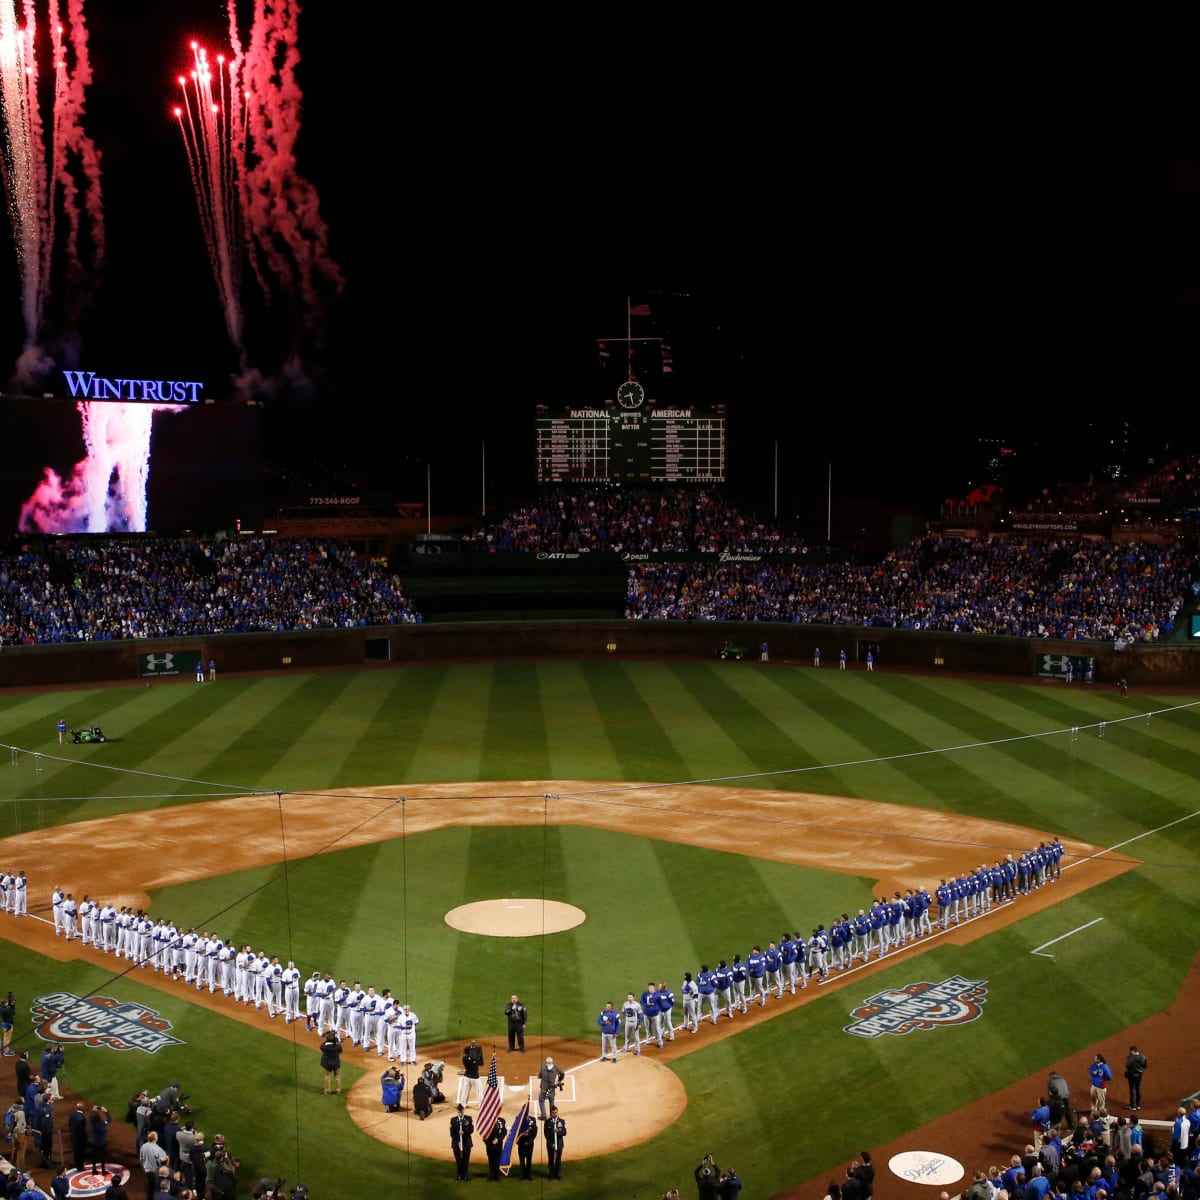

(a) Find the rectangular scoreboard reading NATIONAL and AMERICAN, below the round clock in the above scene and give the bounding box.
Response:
[535,404,726,484]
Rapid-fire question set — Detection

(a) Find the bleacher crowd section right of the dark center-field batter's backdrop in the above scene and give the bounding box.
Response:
[625,534,1194,642]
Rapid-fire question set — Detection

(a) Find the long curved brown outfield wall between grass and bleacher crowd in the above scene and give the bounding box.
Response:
[0,620,1200,689]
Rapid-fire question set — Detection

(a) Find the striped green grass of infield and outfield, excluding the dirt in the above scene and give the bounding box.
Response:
[0,660,1200,1200]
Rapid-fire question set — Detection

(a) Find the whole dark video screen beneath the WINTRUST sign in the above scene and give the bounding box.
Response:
[0,396,263,534]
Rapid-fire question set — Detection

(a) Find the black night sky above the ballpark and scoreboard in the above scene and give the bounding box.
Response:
[0,0,1200,520]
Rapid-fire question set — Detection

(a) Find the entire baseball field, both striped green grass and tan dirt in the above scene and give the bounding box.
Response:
[0,661,1200,1198]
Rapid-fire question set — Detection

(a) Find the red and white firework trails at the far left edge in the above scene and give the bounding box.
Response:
[0,0,106,388]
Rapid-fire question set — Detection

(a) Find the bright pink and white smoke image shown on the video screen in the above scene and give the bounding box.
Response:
[18,400,187,533]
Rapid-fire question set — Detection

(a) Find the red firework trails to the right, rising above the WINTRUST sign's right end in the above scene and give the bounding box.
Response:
[175,0,344,386]
